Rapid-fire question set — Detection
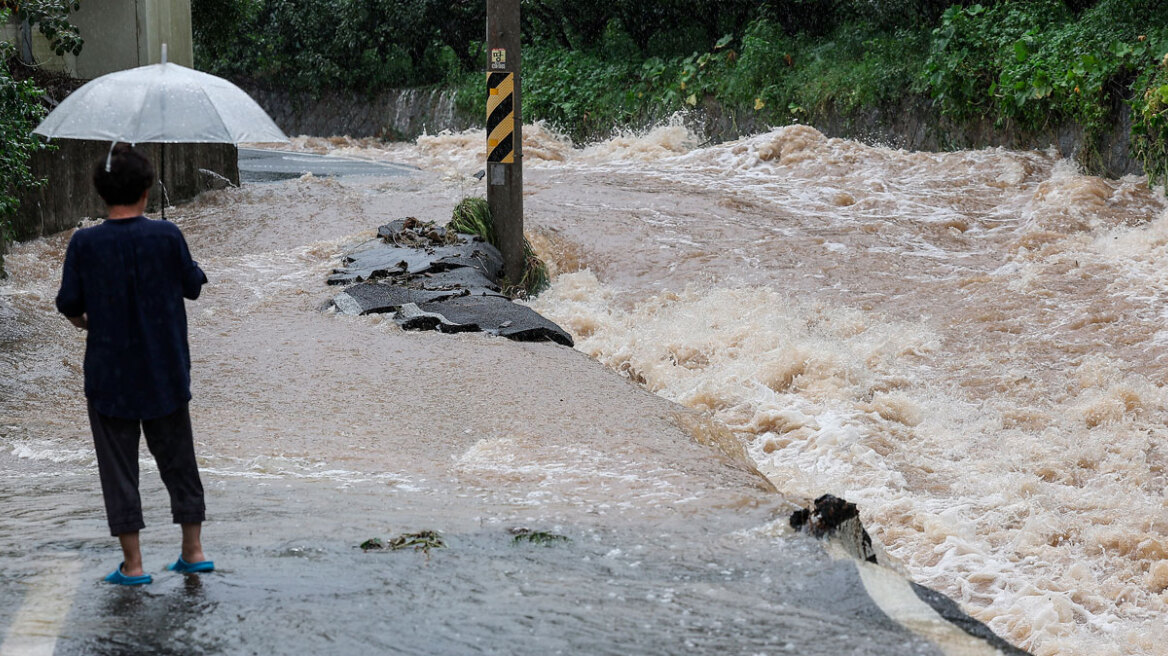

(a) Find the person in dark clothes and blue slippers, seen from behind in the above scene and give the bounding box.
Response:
[56,144,215,585]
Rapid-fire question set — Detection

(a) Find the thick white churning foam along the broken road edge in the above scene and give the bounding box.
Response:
[535,272,1168,654]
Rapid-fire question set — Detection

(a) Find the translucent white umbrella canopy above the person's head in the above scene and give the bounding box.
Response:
[33,60,288,144]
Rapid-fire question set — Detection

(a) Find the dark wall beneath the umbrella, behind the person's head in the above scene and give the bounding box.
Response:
[13,139,239,240]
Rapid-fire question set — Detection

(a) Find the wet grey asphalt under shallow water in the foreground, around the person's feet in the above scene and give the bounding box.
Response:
[0,455,941,656]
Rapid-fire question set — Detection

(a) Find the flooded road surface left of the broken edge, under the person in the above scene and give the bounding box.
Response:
[0,155,993,656]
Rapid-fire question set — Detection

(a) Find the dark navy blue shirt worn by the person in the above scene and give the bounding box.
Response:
[57,216,207,419]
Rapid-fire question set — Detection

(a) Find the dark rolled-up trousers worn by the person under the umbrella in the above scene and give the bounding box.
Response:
[89,404,207,536]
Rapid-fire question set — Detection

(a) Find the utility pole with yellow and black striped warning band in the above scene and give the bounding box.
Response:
[487,0,527,287]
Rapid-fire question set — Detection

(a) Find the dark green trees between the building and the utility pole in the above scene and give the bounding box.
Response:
[192,0,485,93]
